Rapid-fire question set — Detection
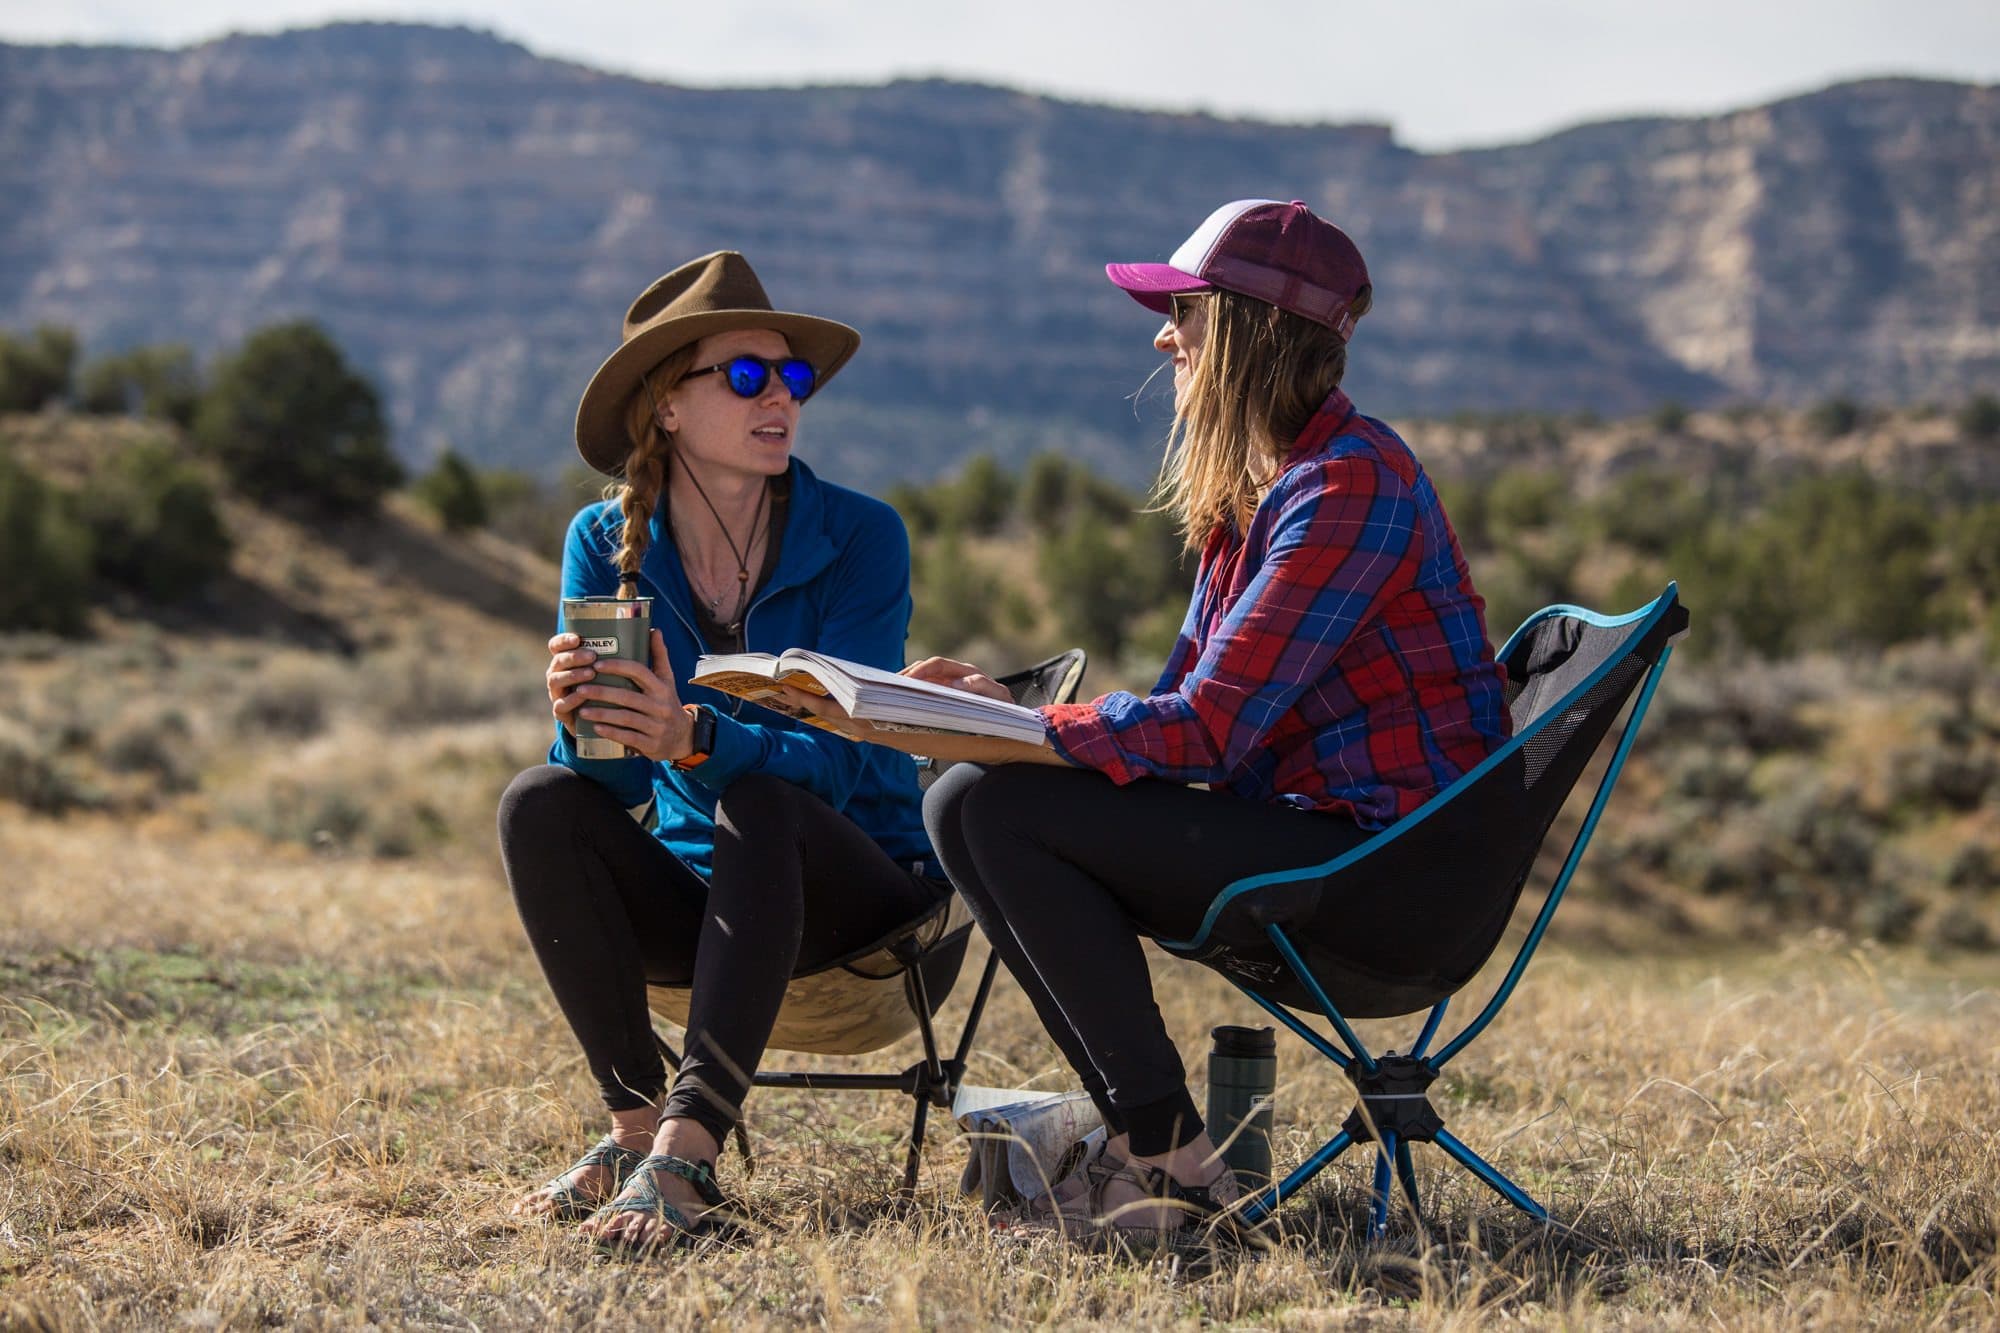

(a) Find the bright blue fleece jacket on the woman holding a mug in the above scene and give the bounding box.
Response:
[548,458,942,879]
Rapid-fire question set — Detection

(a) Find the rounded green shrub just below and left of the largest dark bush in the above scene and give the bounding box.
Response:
[80,442,230,600]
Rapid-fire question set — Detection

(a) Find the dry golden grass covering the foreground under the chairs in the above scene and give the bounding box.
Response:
[0,809,2000,1329]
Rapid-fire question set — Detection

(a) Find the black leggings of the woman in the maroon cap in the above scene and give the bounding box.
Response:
[924,765,1370,1157]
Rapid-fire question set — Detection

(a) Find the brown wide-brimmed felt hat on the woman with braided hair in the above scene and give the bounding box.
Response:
[576,250,862,476]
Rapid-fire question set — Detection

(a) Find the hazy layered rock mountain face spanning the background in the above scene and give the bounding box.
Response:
[0,24,2000,484]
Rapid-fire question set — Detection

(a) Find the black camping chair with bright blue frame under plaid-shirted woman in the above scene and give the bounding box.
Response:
[1158,584,1688,1237]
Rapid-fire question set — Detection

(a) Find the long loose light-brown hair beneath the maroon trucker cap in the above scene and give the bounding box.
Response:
[1154,286,1370,552]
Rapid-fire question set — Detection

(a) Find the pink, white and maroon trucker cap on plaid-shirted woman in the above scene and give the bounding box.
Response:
[1104,198,1368,340]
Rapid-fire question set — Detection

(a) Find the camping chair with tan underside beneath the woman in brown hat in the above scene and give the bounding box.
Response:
[646,648,1086,1195]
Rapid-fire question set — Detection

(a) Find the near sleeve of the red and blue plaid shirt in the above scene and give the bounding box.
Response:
[1042,454,1420,785]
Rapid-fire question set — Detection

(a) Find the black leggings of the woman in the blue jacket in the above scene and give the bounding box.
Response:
[500,767,946,1141]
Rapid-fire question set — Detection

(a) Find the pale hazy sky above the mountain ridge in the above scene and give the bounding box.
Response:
[0,0,2000,148]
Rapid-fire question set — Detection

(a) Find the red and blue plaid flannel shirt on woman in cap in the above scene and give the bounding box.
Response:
[1042,390,1510,829]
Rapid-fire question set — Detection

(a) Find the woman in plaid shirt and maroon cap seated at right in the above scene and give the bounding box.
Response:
[788,200,1508,1229]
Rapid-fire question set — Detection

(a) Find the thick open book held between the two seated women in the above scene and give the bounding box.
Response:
[694,648,1048,745]
